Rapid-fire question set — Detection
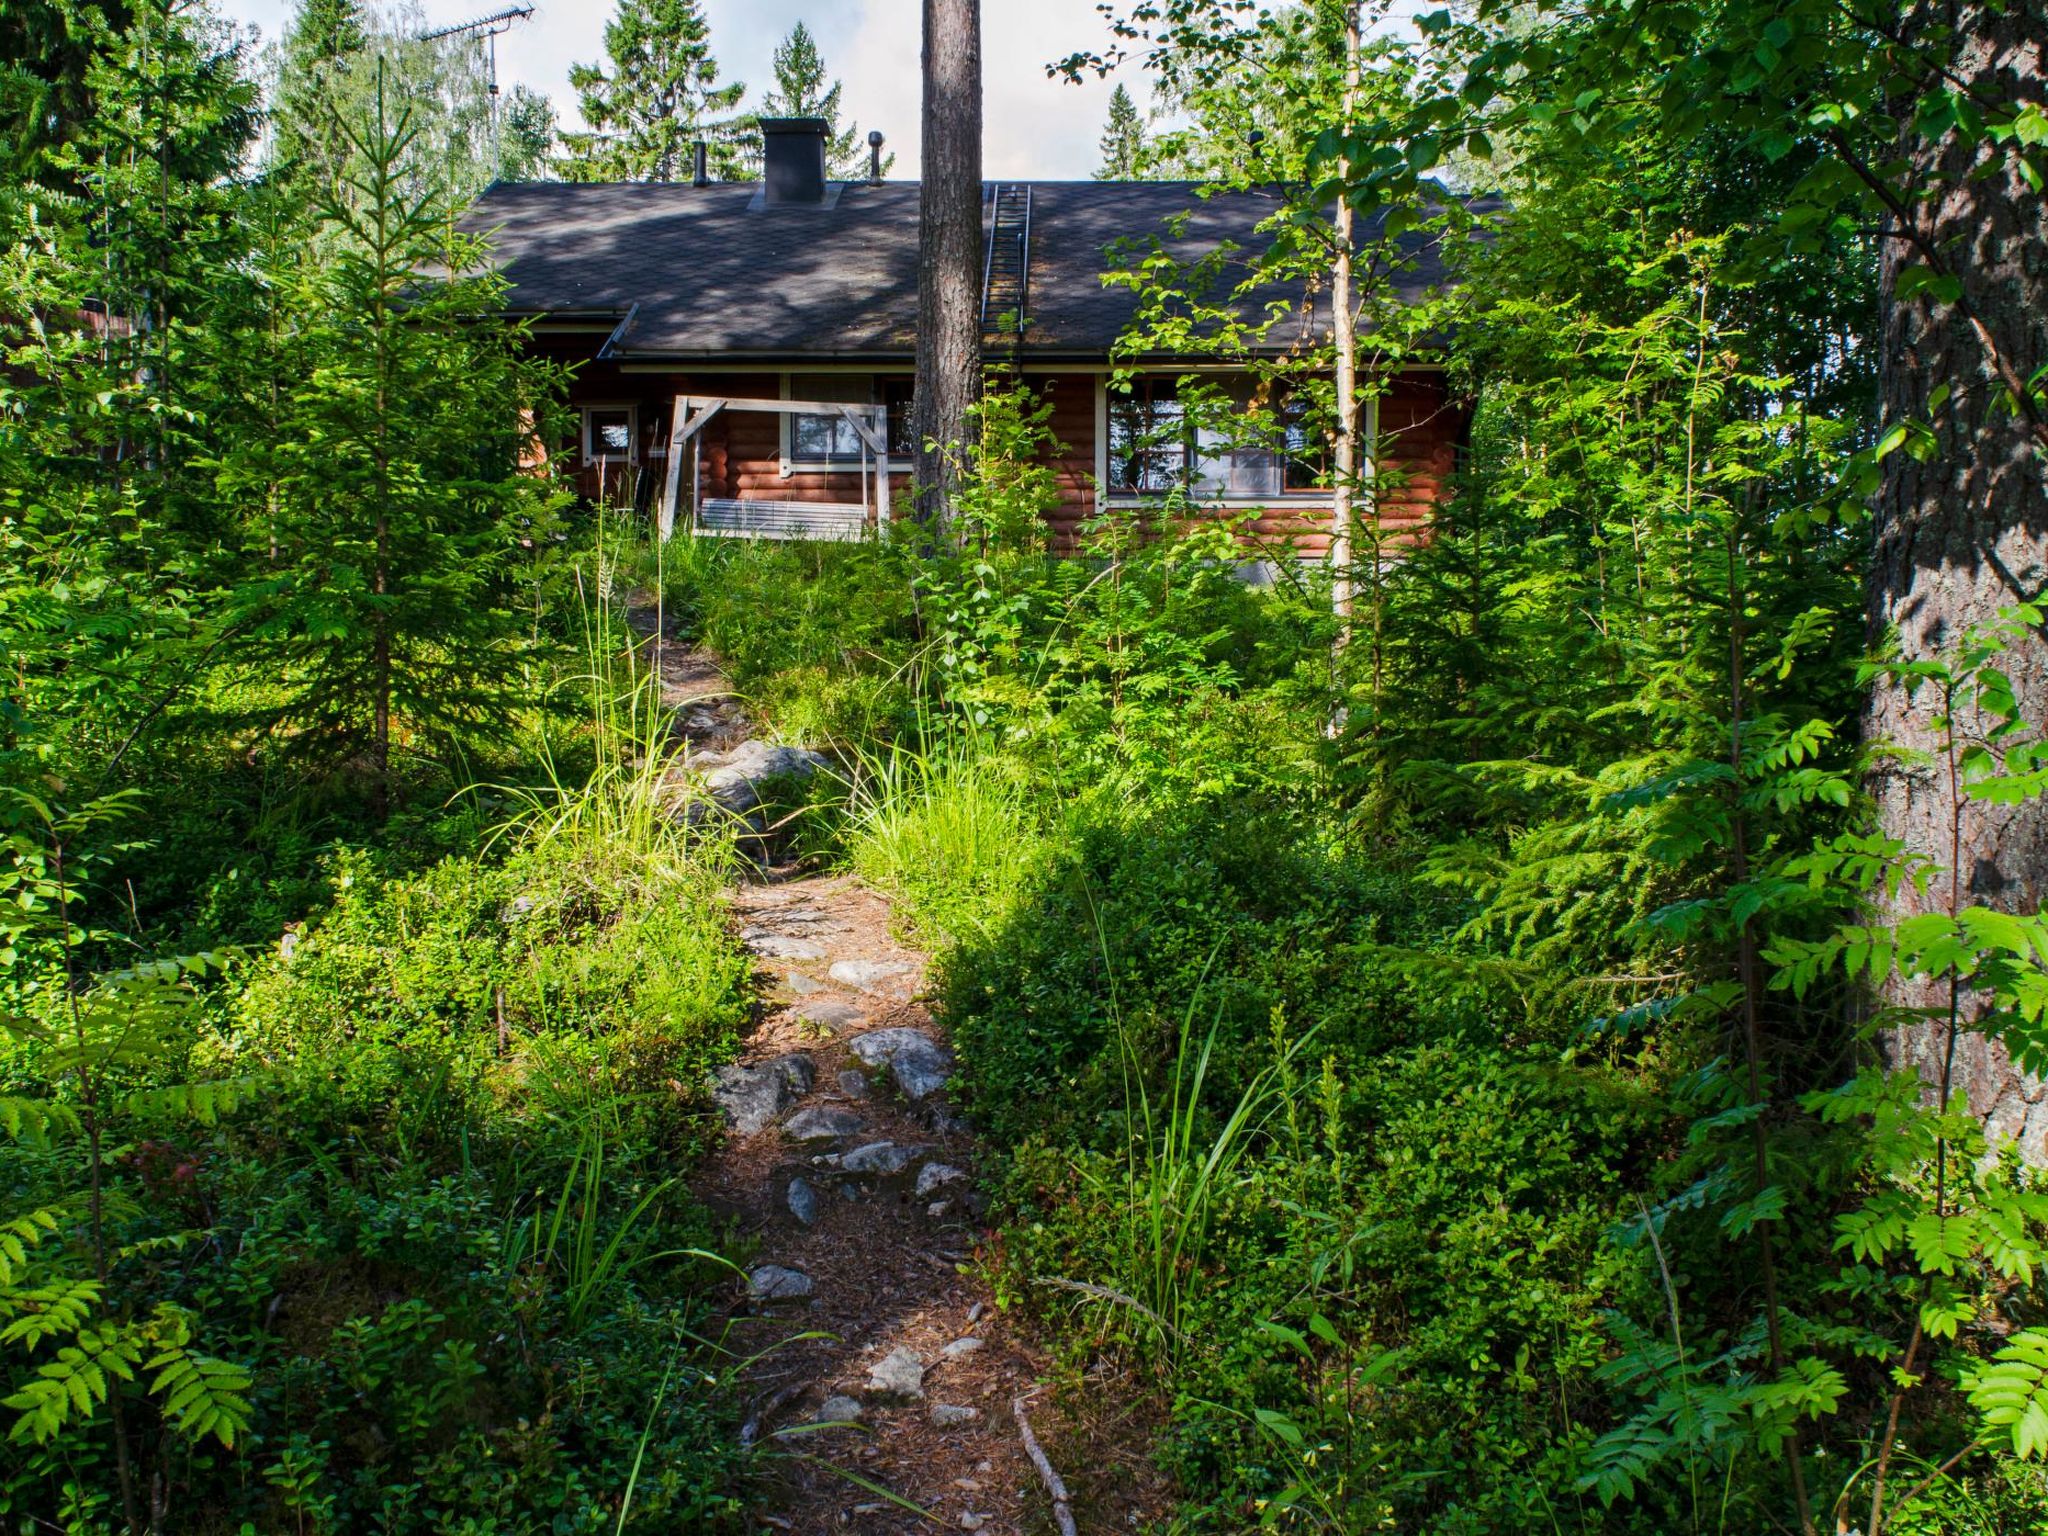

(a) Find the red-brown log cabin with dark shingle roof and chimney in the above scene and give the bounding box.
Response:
[465,119,1468,557]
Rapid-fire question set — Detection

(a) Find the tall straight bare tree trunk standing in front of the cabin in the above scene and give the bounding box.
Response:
[911,0,981,526]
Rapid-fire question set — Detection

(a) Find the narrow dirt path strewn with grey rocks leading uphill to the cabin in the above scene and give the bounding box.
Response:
[664,626,1089,1536]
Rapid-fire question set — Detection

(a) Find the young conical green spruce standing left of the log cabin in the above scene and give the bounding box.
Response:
[244,69,569,811]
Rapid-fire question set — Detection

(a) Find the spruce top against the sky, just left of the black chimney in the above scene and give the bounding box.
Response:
[563,0,745,182]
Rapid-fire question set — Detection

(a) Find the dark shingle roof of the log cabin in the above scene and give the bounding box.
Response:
[465,182,1482,358]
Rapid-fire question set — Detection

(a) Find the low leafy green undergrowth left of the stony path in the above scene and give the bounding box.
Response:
[0,798,745,1532]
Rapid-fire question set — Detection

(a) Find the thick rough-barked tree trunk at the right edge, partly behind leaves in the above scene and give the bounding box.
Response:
[1866,0,2048,1161]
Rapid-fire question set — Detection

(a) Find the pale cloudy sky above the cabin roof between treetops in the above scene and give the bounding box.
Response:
[215,0,1145,180]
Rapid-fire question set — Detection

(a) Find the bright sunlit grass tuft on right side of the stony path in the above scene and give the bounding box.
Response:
[848,731,1047,942]
